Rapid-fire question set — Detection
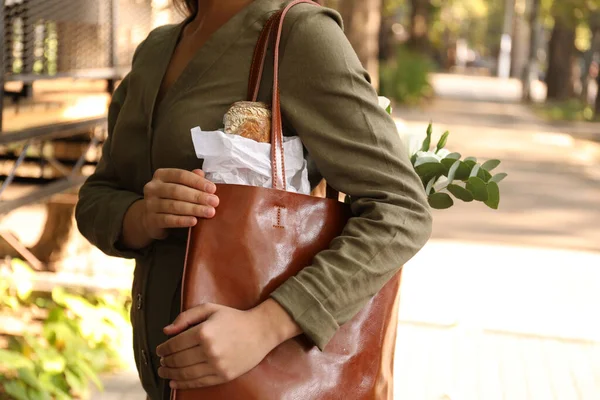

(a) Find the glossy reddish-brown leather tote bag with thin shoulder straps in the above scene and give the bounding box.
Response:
[172,0,400,400]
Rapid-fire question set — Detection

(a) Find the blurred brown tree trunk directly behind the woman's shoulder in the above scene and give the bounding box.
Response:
[339,0,383,88]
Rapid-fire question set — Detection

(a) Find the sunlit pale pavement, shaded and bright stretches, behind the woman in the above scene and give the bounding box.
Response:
[93,75,600,400]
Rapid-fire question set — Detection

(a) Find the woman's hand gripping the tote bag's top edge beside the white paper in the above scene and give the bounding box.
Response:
[121,169,219,249]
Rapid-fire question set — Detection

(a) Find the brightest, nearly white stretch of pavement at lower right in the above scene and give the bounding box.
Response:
[396,241,600,400]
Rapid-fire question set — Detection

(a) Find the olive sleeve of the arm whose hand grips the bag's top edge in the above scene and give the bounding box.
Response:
[75,45,143,258]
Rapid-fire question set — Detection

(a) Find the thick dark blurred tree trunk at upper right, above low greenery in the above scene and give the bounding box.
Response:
[546,18,575,100]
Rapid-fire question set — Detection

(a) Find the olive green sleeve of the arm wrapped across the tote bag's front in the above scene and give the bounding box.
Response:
[271,6,432,349]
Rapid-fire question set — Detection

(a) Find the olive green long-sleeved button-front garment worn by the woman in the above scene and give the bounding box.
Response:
[76,0,431,399]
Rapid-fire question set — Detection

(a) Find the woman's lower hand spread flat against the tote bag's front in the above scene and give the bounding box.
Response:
[156,299,301,389]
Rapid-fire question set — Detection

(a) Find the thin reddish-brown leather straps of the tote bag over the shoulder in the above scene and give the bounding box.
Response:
[248,0,339,200]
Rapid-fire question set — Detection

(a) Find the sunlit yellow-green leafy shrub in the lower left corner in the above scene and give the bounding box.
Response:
[0,260,131,400]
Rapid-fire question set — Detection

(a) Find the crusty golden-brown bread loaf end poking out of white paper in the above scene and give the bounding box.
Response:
[223,101,271,143]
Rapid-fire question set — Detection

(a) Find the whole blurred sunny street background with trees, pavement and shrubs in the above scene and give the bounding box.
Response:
[0,0,600,400]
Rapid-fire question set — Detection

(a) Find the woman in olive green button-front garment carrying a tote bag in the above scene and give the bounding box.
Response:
[77,0,431,399]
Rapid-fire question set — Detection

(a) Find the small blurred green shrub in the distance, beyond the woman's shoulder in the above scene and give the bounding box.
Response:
[380,47,434,105]
